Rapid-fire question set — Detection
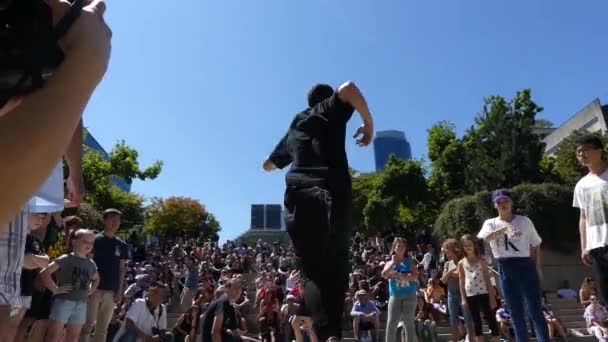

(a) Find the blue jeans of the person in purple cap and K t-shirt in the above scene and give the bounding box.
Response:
[497,258,549,342]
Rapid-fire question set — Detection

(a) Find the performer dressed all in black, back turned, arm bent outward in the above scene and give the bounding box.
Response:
[263,82,374,340]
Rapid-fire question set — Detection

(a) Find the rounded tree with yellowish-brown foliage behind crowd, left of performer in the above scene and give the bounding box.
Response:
[144,197,221,237]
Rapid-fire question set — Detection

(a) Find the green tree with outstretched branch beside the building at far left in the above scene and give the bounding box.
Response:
[82,141,162,228]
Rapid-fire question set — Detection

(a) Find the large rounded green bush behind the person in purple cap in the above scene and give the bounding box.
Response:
[433,183,579,252]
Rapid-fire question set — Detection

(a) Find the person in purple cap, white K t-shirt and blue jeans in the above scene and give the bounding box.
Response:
[477,189,550,342]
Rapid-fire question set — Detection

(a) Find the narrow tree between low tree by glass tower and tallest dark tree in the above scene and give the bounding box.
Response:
[427,121,466,203]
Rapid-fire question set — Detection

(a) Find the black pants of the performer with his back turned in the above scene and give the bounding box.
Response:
[285,181,352,339]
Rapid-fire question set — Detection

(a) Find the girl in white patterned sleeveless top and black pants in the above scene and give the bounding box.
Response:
[458,234,499,342]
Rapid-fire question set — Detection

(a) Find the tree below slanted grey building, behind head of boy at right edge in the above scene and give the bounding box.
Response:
[554,130,608,186]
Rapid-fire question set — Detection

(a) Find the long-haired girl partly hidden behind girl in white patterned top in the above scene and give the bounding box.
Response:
[441,239,473,341]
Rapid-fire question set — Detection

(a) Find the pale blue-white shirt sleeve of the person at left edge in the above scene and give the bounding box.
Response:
[29,161,64,213]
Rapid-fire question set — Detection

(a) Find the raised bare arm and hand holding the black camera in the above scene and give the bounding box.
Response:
[0,2,110,226]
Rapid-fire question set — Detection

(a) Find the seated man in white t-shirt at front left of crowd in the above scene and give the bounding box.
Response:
[114,282,173,342]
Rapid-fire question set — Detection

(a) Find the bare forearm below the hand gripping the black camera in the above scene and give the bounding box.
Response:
[0,49,101,224]
